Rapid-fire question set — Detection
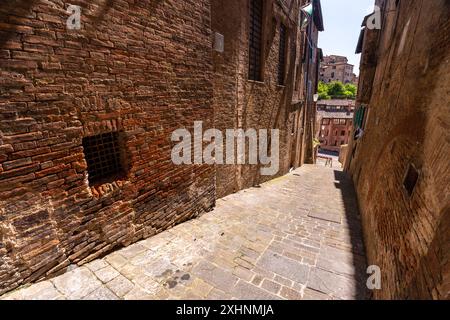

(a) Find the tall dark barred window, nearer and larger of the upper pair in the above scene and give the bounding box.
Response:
[248,0,263,81]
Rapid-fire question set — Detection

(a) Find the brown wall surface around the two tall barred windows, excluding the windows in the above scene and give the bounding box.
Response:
[212,0,317,197]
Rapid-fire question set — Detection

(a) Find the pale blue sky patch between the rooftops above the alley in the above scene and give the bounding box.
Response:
[319,0,375,74]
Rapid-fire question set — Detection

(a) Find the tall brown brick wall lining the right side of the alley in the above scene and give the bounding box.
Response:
[350,0,450,299]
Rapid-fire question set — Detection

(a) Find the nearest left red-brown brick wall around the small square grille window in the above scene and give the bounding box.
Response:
[0,0,216,294]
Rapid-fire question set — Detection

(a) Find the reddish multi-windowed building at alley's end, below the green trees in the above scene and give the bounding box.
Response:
[317,100,355,151]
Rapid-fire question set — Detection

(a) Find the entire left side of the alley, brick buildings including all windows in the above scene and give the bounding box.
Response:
[0,0,323,294]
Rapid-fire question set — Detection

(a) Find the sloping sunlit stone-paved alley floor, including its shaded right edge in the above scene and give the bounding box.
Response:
[3,165,367,300]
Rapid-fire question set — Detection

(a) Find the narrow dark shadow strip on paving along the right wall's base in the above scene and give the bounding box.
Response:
[334,171,371,300]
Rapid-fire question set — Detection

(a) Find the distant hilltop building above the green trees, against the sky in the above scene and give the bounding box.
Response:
[320,55,358,84]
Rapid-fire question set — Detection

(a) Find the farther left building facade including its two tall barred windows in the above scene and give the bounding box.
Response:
[212,0,323,197]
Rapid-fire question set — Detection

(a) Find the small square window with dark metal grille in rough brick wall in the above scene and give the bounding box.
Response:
[83,132,124,185]
